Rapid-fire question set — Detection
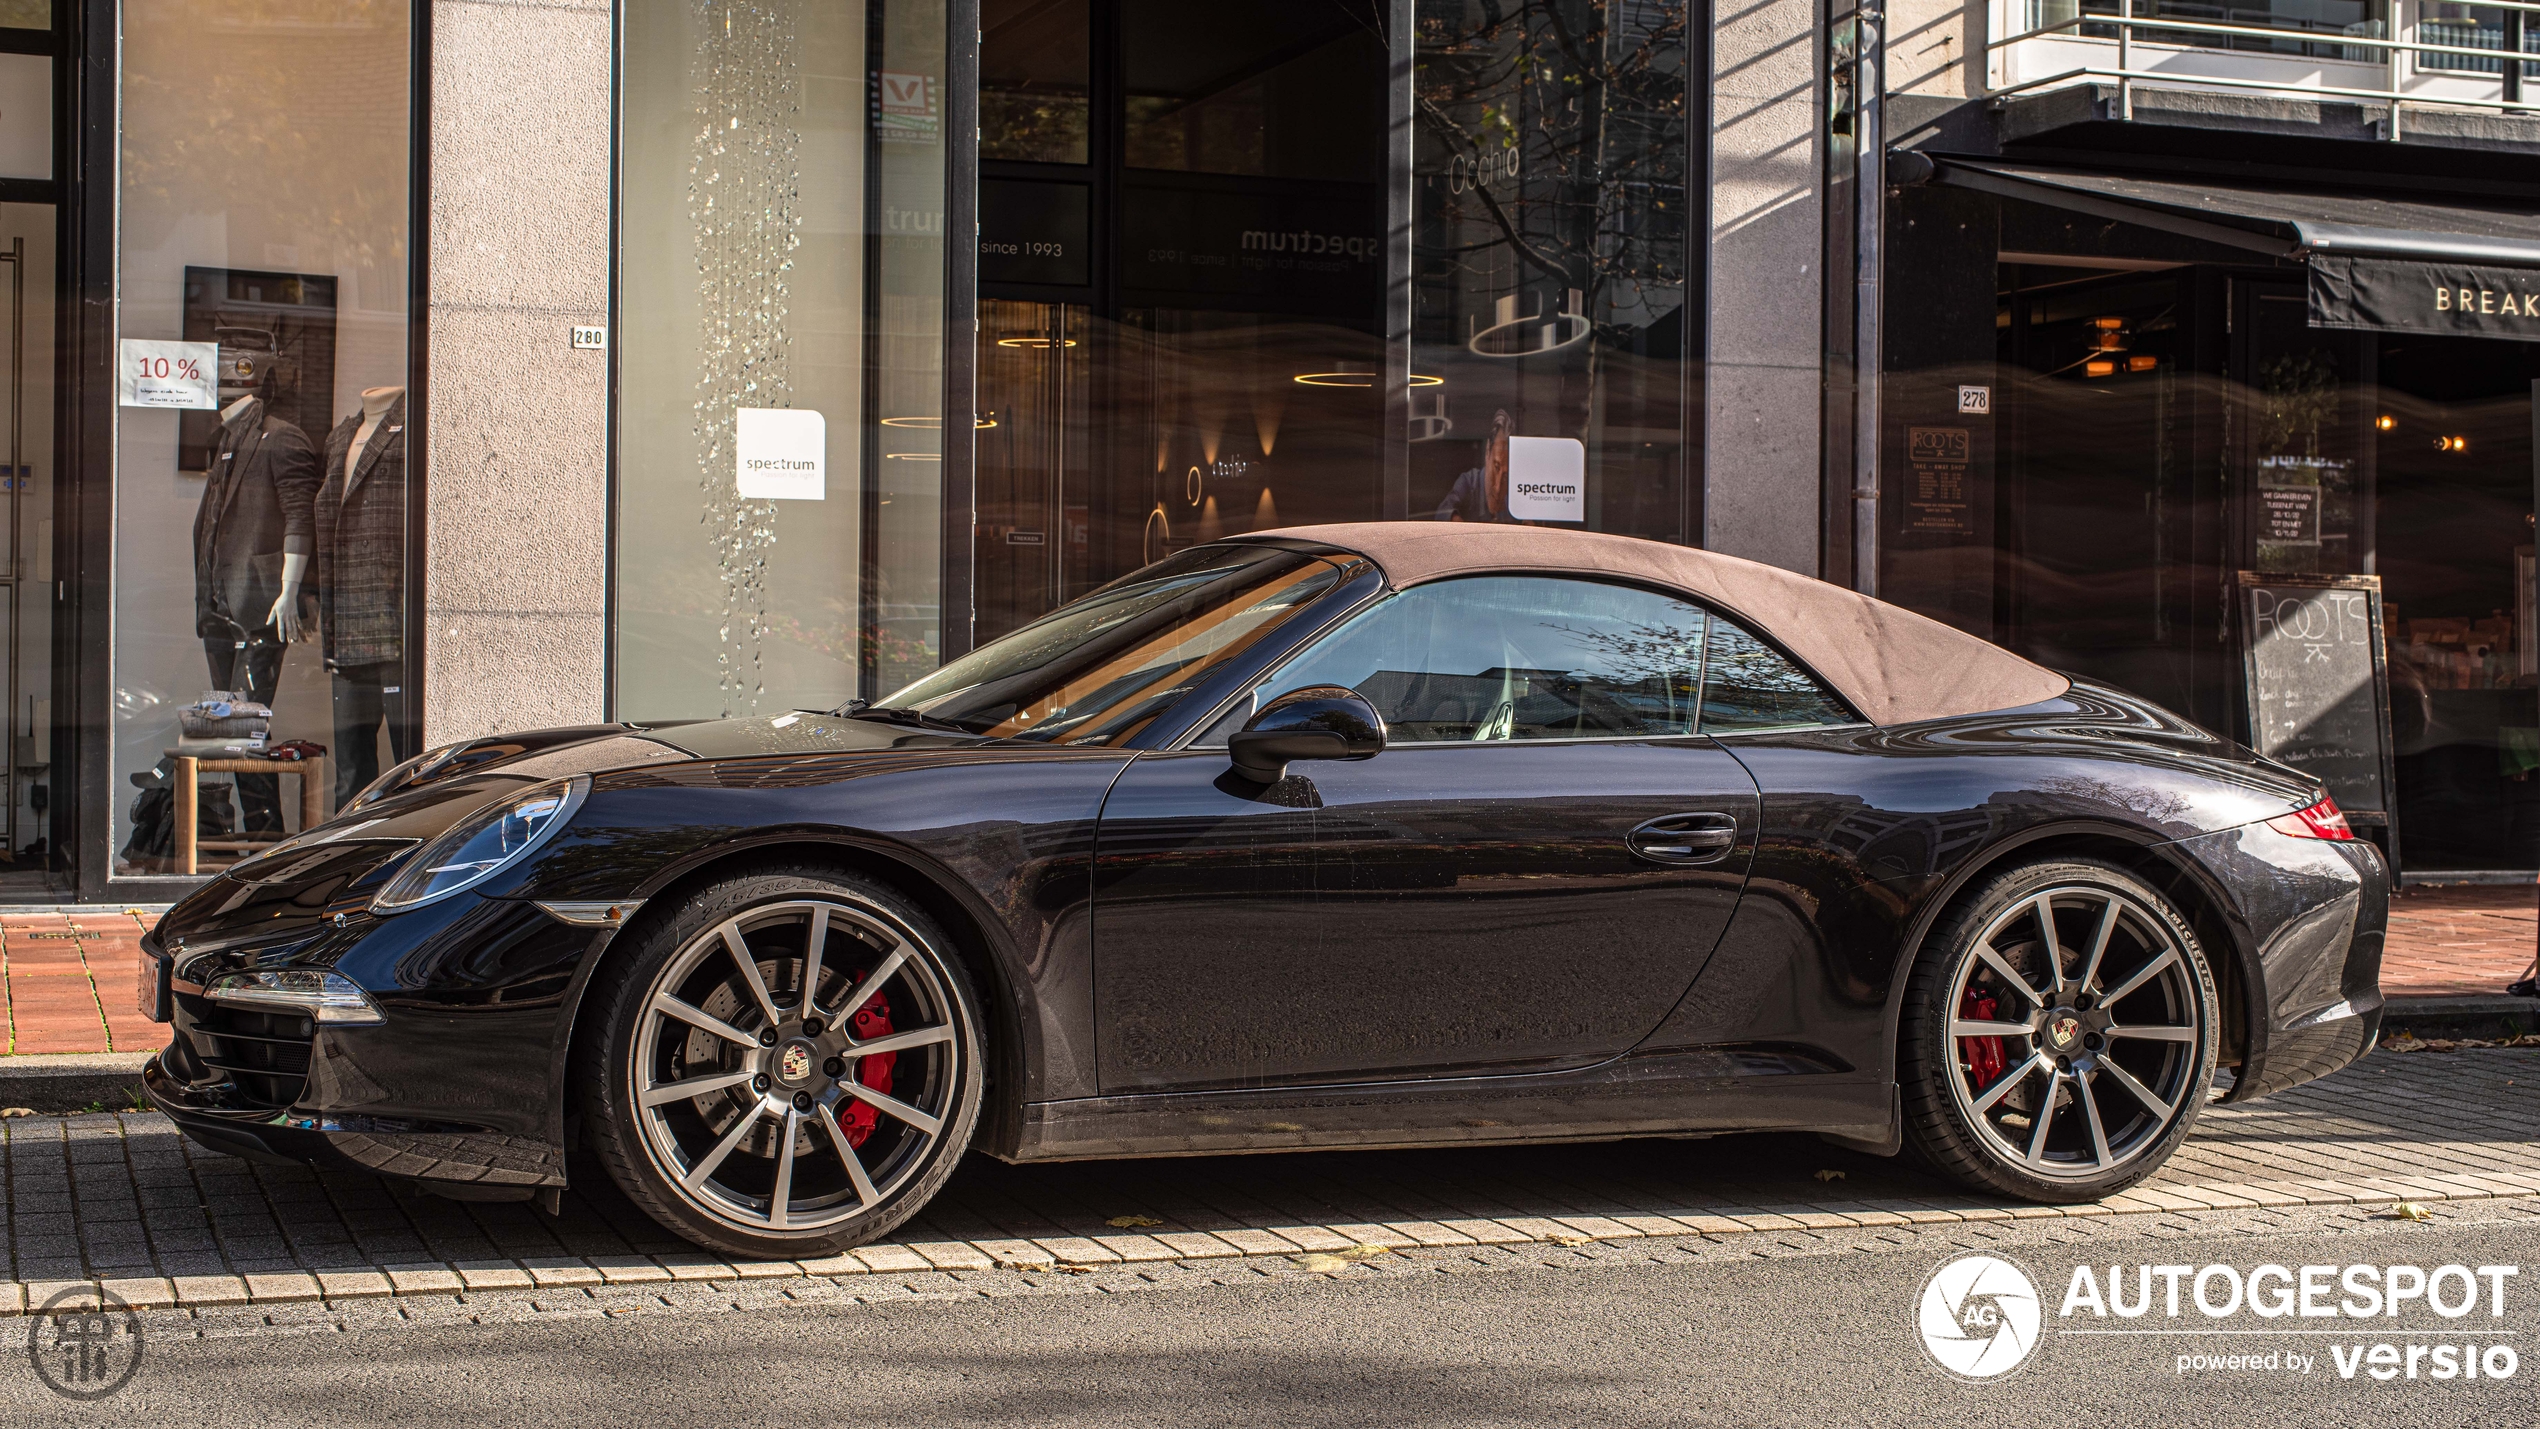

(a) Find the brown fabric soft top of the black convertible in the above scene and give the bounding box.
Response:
[1255,520,2073,723]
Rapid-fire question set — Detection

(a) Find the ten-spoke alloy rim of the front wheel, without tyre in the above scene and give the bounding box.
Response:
[627,899,970,1234]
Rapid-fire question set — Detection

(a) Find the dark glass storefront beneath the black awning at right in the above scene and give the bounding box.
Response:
[1880,178,2540,873]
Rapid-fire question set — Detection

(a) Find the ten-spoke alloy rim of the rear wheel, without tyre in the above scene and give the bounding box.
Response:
[1948,883,2210,1180]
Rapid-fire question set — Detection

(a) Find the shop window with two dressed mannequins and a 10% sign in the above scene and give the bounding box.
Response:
[113,0,419,876]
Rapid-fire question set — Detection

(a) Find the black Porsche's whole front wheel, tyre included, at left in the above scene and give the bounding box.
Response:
[579,871,980,1259]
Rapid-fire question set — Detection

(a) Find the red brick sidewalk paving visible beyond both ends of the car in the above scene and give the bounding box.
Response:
[0,883,2540,1053]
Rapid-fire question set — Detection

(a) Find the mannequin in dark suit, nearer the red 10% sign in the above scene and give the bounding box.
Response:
[193,388,320,835]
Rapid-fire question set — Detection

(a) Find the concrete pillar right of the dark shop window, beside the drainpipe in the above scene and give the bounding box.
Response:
[1702,0,1826,576]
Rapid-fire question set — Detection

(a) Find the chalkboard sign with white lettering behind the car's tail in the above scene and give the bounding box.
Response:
[2240,571,2393,827]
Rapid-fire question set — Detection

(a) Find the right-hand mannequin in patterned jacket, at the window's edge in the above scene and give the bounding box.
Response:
[318,386,414,805]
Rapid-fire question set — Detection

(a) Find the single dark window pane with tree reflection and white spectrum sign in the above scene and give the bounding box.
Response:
[1410,0,1699,543]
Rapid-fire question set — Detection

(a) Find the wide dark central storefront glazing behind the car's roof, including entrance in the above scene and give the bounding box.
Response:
[975,0,1699,640]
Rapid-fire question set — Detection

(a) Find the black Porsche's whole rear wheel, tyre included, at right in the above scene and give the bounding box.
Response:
[1897,860,2217,1201]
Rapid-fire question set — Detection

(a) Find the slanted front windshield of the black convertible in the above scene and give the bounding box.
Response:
[876,546,1361,744]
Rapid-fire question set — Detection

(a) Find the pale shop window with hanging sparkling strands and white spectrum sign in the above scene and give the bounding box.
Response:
[615,0,955,718]
